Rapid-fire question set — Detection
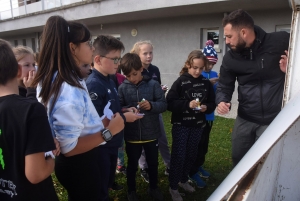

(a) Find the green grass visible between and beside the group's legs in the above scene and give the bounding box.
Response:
[52,112,234,201]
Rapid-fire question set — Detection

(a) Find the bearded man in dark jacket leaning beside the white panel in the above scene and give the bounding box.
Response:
[216,9,289,166]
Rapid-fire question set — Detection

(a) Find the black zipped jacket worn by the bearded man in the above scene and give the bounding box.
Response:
[216,26,289,125]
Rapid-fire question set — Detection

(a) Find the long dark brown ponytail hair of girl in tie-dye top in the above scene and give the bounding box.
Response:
[33,16,90,111]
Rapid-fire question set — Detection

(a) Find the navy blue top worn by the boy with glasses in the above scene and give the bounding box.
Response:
[86,69,124,147]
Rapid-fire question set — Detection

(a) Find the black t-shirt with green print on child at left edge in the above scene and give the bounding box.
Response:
[0,95,58,201]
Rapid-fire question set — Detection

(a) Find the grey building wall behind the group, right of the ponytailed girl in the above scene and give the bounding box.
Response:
[89,10,291,86]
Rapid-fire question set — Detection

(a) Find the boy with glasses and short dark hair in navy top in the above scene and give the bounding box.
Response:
[86,35,142,200]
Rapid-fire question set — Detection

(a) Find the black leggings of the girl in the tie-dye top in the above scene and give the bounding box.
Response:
[55,148,100,201]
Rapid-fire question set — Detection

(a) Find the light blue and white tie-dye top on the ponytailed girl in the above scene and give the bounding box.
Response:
[37,75,104,154]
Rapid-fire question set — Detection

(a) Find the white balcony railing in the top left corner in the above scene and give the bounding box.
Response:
[0,0,85,21]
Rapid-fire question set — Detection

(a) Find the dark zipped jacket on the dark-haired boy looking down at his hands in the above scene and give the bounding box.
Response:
[119,76,167,141]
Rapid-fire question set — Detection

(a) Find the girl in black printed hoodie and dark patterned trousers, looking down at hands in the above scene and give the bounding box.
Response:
[167,50,216,200]
